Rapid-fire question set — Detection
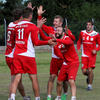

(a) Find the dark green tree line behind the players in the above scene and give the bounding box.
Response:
[0,0,100,45]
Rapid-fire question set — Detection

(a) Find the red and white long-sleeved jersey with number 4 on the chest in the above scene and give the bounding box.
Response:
[77,30,100,57]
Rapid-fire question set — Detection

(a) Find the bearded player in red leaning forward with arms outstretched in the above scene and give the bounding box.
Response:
[54,27,79,100]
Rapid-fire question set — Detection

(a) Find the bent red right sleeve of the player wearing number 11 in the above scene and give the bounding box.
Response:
[31,26,48,46]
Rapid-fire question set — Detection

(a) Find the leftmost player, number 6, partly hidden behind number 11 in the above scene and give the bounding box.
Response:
[5,9,30,100]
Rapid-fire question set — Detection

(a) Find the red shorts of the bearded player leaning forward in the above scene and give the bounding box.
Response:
[57,61,79,81]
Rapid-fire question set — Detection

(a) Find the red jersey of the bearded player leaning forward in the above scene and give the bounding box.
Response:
[55,36,78,62]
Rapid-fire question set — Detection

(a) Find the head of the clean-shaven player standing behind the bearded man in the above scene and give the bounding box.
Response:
[53,15,63,28]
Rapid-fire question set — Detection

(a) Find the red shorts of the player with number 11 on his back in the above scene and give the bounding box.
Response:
[13,55,37,74]
